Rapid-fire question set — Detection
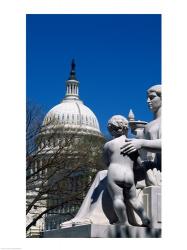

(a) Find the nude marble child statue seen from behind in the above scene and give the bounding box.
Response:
[104,115,150,226]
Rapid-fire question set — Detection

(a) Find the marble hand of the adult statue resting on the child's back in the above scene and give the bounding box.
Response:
[121,139,142,155]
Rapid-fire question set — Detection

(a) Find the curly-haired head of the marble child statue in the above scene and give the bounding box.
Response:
[108,115,129,137]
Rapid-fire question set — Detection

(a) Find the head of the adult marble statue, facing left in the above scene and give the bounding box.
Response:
[147,84,162,113]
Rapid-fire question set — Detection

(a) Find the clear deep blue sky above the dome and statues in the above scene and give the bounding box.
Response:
[26,14,161,134]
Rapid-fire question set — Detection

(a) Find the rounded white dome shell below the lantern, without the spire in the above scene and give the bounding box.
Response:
[43,99,101,134]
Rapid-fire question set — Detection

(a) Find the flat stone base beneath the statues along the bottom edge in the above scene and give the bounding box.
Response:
[43,224,161,238]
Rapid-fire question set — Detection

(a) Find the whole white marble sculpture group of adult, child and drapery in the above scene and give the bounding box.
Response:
[61,85,161,227]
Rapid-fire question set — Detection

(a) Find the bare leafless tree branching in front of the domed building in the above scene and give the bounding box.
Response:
[26,102,105,234]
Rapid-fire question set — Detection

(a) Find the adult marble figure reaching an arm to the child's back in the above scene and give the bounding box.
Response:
[121,85,162,186]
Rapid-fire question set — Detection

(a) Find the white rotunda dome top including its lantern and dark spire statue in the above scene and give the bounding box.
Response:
[43,61,102,136]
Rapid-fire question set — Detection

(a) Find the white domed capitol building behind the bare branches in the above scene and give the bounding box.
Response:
[27,60,105,237]
